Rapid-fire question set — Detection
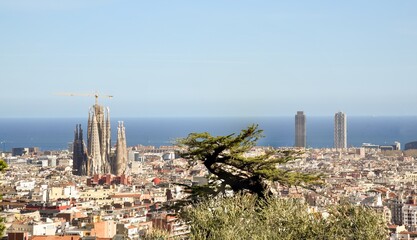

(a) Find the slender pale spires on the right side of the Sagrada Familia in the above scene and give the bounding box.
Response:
[113,122,127,176]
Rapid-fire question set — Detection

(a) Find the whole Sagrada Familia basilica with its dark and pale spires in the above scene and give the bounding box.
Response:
[73,102,128,176]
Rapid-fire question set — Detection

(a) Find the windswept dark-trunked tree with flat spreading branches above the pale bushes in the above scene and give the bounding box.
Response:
[178,125,321,199]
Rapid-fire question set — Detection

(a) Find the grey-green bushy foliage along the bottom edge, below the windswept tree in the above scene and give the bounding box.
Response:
[180,194,387,240]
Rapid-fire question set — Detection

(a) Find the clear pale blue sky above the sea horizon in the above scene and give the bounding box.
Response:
[0,0,417,117]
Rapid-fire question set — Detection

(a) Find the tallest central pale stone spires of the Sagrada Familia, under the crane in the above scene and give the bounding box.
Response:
[87,103,111,176]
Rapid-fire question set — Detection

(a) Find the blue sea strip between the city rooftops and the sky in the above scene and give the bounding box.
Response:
[0,116,417,151]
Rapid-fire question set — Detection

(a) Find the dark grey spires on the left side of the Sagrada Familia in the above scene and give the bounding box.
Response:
[72,124,88,176]
